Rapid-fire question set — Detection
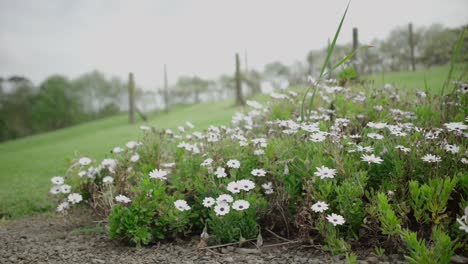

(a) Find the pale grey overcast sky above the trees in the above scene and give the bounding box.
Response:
[0,0,468,89]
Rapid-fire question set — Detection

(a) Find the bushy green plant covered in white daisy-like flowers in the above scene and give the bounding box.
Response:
[50,80,468,259]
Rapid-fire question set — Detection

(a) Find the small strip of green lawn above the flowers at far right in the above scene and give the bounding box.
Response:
[365,64,468,93]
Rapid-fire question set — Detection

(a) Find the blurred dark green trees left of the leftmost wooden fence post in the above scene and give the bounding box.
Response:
[0,71,127,141]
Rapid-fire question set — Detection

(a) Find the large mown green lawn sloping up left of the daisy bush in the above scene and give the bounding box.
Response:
[0,101,238,218]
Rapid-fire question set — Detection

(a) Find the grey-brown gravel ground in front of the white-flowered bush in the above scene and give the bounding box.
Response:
[0,213,403,264]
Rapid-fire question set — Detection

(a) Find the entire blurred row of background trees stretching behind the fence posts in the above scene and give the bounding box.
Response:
[0,24,468,141]
